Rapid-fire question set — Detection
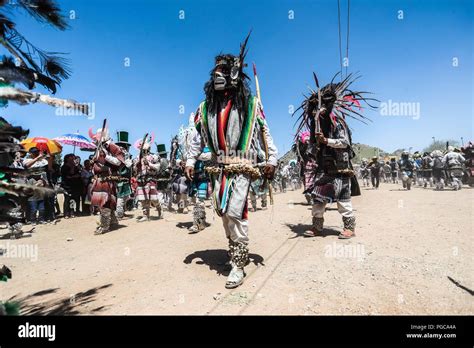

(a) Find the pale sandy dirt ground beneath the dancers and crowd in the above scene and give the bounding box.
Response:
[0,184,474,315]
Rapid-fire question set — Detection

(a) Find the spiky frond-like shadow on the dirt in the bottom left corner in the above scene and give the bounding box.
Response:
[8,284,112,315]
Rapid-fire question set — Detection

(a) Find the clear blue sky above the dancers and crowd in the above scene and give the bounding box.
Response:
[0,0,474,154]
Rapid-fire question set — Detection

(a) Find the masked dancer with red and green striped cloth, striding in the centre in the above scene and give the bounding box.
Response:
[182,36,277,288]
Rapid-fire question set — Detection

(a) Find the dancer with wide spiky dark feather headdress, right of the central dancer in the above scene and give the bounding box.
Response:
[296,74,372,239]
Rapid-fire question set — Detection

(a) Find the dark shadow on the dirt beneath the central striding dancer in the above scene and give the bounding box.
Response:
[183,249,265,275]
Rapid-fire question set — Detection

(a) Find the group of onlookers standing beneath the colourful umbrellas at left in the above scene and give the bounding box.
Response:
[13,147,94,225]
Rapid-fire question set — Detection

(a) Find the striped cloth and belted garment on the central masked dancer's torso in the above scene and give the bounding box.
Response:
[195,97,265,219]
